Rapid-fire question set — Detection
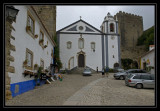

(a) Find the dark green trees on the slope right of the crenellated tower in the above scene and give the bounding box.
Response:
[137,26,154,50]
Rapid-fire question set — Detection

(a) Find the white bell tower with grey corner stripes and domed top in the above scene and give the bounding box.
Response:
[101,12,121,68]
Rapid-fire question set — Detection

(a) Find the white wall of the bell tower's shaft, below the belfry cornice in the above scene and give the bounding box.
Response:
[108,35,119,68]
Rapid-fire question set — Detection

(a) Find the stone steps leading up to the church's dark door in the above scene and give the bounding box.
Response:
[67,66,96,74]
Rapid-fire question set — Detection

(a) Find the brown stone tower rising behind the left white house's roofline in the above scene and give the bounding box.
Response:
[33,5,56,40]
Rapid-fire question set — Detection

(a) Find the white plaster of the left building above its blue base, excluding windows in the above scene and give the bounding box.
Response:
[9,6,53,84]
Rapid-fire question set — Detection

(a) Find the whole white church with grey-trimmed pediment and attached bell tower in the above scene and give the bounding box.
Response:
[57,13,121,71]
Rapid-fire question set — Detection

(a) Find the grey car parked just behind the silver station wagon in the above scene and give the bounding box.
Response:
[113,69,146,80]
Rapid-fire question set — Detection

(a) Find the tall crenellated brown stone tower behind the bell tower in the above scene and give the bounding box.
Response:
[114,11,145,59]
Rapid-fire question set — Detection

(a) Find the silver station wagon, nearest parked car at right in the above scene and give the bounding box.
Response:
[125,73,155,89]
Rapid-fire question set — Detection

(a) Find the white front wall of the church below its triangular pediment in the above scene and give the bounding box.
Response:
[59,34,102,70]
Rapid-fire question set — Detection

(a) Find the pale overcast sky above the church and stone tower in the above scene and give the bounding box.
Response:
[56,5,155,31]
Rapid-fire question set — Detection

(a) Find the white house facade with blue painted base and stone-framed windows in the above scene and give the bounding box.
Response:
[6,5,56,97]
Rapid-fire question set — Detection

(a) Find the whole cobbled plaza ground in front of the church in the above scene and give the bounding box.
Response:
[6,73,155,106]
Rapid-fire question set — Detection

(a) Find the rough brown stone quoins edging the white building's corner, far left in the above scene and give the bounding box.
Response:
[5,19,16,100]
